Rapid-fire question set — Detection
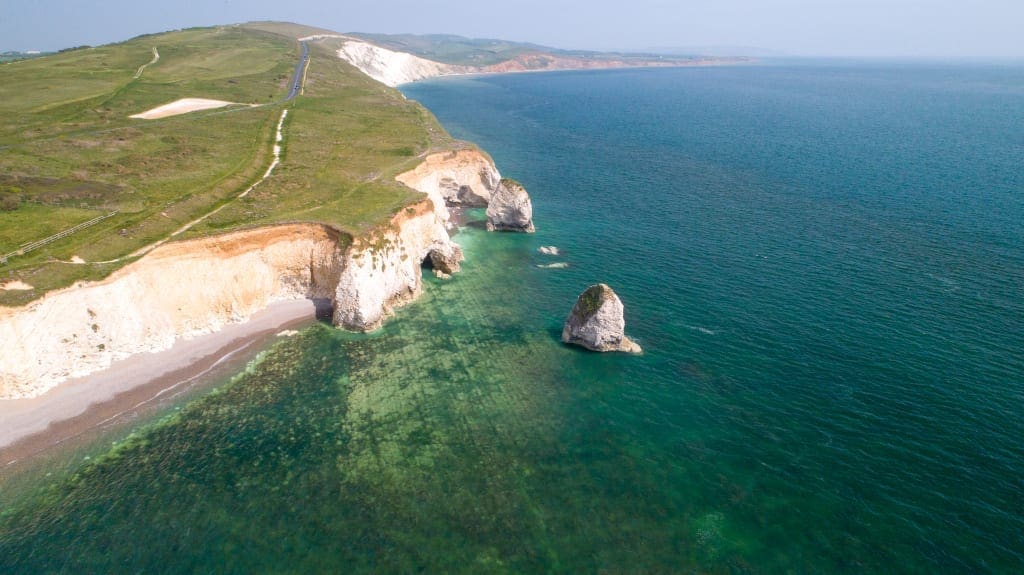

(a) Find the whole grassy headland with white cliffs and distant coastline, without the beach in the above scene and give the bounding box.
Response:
[0,23,721,425]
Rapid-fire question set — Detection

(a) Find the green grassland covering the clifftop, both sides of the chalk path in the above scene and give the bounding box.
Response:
[0,23,453,306]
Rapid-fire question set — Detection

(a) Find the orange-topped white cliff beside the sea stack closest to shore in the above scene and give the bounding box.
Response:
[395,149,502,222]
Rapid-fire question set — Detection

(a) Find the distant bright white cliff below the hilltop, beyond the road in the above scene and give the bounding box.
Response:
[338,40,469,88]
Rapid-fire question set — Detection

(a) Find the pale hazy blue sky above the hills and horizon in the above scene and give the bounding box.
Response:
[0,0,1024,59]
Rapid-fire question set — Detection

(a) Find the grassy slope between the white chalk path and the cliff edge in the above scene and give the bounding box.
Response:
[196,34,454,233]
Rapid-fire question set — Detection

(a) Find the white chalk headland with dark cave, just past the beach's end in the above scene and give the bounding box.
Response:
[334,201,462,331]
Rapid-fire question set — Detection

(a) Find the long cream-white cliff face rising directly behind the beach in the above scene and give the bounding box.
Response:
[0,225,343,399]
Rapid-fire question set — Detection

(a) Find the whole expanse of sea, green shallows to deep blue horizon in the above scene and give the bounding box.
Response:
[0,62,1024,574]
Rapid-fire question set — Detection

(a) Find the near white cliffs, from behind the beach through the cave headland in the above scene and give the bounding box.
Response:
[0,200,462,399]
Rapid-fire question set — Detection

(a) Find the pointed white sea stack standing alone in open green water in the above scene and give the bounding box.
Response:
[562,283,642,353]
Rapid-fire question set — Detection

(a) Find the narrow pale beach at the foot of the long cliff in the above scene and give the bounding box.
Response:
[0,300,316,468]
